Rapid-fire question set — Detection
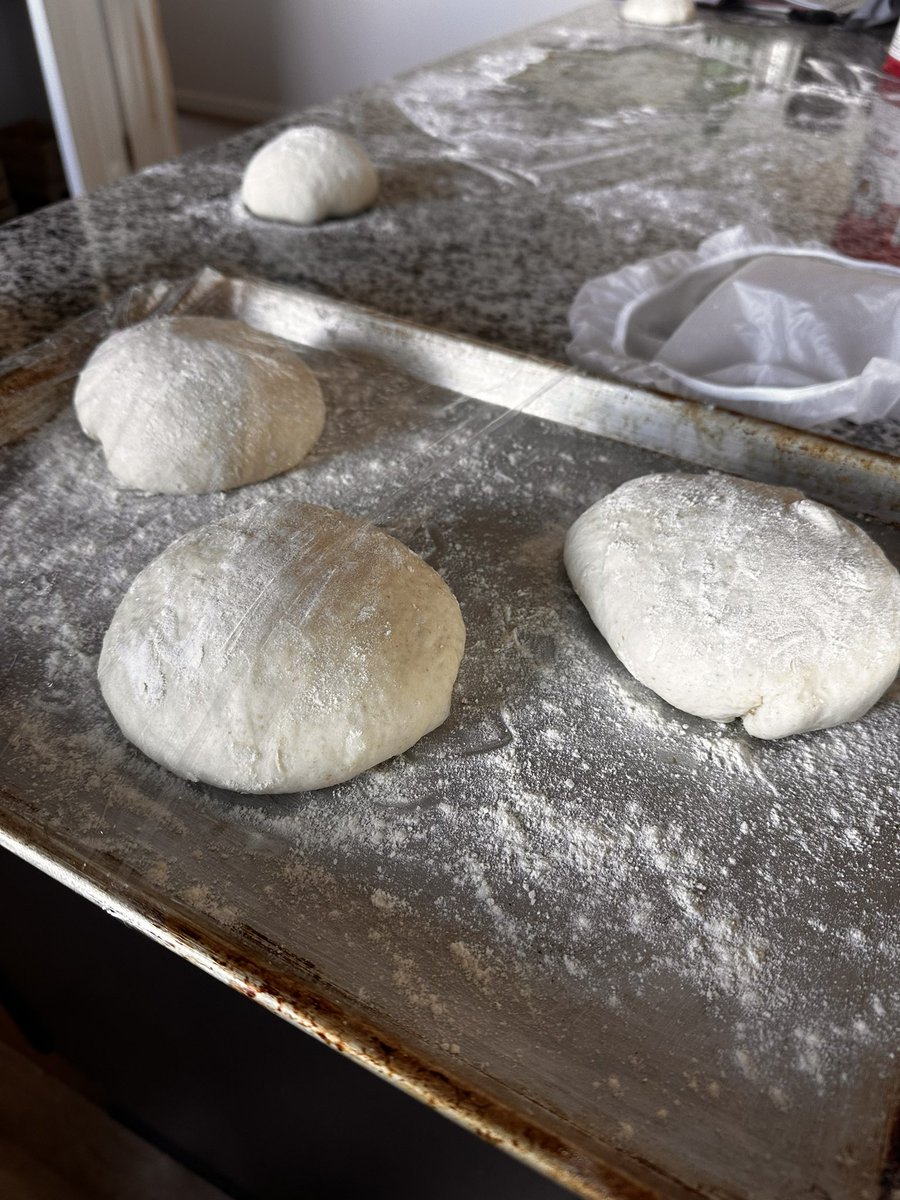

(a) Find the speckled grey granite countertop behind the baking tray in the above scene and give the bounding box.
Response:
[0,4,883,359]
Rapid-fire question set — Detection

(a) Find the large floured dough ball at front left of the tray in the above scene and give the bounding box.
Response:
[98,503,466,792]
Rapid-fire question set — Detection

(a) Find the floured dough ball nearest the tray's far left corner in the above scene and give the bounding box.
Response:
[74,317,325,494]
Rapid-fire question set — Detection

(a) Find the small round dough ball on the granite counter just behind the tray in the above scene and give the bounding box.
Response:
[241,125,378,224]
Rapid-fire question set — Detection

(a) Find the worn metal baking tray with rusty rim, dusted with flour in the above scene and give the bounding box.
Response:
[0,272,900,1200]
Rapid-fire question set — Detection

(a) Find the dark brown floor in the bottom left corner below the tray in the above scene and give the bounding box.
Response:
[0,1010,226,1200]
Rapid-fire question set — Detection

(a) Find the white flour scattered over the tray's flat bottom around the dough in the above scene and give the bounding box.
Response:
[0,326,900,1190]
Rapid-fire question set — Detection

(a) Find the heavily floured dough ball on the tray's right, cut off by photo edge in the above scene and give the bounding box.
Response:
[565,474,900,738]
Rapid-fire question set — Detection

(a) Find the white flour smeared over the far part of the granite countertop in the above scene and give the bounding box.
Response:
[391,11,876,252]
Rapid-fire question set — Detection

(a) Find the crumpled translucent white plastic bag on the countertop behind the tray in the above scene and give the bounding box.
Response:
[569,226,900,428]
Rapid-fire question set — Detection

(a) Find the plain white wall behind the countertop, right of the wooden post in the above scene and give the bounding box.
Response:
[160,0,578,120]
